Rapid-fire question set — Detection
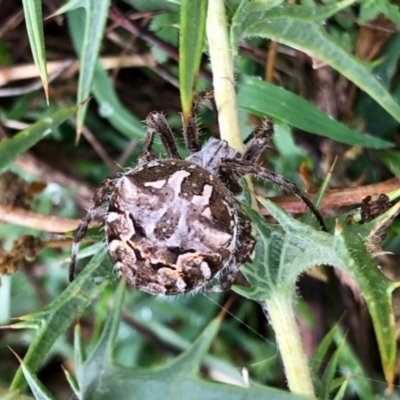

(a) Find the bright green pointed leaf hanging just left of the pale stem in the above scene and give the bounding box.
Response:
[179,0,208,126]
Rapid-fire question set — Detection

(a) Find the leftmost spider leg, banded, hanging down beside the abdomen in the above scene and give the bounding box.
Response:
[69,179,113,282]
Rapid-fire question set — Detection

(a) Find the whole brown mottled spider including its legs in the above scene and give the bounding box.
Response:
[70,92,323,295]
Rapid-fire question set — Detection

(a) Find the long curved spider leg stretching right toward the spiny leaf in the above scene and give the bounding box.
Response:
[221,159,327,231]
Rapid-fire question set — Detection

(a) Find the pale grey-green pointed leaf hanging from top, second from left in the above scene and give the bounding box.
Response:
[68,0,111,133]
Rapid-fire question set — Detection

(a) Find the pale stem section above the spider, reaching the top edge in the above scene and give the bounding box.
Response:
[206,0,244,153]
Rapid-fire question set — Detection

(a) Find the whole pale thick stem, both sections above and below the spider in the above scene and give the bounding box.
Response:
[206,0,315,397]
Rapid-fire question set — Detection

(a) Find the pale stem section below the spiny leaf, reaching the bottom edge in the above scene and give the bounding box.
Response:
[265,290,315,398]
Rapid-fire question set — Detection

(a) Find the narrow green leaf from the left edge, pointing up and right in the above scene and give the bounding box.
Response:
[0,105,79,173]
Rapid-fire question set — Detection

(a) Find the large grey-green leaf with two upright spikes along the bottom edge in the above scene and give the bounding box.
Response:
[77,282,299,400]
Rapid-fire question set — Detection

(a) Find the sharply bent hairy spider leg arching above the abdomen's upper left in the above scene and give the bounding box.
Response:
[145,112,182,160]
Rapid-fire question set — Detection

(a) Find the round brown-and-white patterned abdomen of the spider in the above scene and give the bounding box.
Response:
[105,159,238,294]
